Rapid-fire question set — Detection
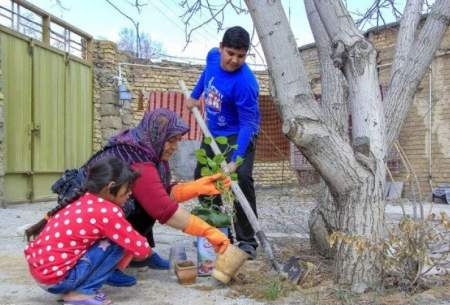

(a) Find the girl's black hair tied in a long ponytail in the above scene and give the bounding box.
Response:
[25,157,139,240]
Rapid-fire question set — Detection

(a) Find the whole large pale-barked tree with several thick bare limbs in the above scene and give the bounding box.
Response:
[179,0,450,292]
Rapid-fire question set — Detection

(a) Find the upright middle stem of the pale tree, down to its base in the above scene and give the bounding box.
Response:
[305,0,386,292]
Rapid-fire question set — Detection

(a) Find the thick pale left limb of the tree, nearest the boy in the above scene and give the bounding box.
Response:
[246,0,366,193]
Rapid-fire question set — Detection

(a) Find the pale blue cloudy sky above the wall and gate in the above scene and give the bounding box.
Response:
[0,0,404,64]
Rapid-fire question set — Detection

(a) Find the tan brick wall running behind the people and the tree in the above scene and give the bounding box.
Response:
[93,22,450,194]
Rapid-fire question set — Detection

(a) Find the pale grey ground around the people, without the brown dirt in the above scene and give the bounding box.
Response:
[0,188,450,305]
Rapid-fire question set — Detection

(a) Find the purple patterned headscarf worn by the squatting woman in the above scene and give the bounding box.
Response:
[89,108,189,189]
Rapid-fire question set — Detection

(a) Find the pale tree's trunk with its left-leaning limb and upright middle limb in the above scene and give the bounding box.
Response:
[246,0,384,292]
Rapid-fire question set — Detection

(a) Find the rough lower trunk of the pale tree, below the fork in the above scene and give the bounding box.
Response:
[335,169,385,292]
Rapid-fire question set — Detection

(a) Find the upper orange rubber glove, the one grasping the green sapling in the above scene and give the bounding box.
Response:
[170,174,231,202]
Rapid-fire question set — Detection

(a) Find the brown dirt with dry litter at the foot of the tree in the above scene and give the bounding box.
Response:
[221,238,450,305]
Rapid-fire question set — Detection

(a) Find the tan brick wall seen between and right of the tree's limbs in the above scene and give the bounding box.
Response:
[301,26,450,199]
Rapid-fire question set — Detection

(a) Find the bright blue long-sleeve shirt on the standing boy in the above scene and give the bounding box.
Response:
[191,48,260,161]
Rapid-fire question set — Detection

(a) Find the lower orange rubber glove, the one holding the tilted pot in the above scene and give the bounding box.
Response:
[183,215,230,253]
